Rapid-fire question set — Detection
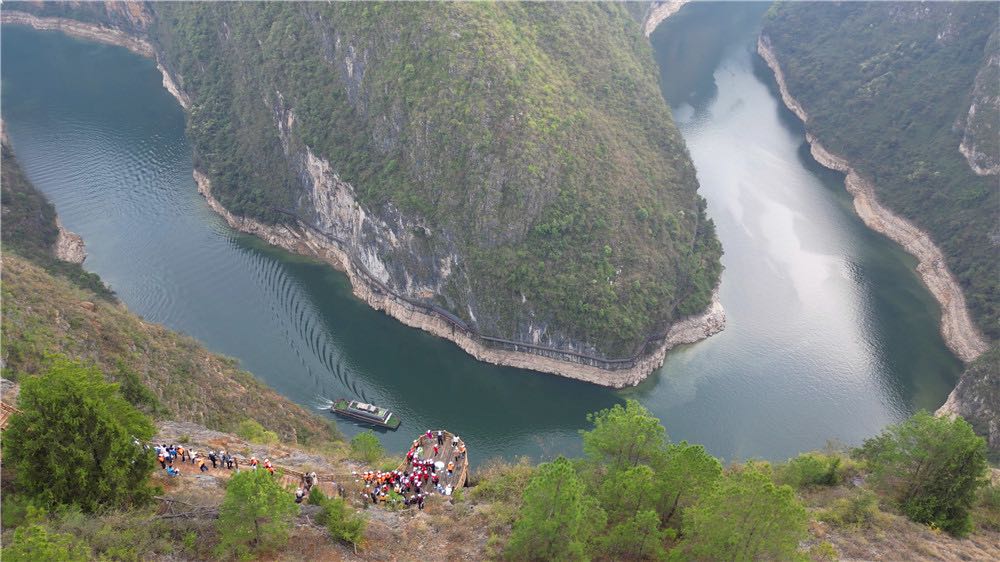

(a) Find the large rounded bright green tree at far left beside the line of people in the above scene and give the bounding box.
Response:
[4,358,154,512]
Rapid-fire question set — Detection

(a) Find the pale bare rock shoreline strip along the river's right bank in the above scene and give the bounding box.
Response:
[757,34,989,363]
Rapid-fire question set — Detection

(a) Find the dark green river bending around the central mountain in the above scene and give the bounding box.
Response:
[2,4,961,462]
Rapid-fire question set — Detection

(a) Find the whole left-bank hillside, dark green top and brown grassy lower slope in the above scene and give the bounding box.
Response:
[0,152,337,443]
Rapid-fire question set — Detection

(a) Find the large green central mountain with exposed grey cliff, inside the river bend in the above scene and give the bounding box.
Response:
[7,3,721,357]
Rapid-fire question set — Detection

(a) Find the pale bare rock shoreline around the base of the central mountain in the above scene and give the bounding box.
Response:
[2,13,726,388]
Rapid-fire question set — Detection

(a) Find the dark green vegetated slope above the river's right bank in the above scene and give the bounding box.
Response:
[763,2,1000,340]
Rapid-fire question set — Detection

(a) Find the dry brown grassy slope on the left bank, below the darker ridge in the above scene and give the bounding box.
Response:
[2,252,337,446]
